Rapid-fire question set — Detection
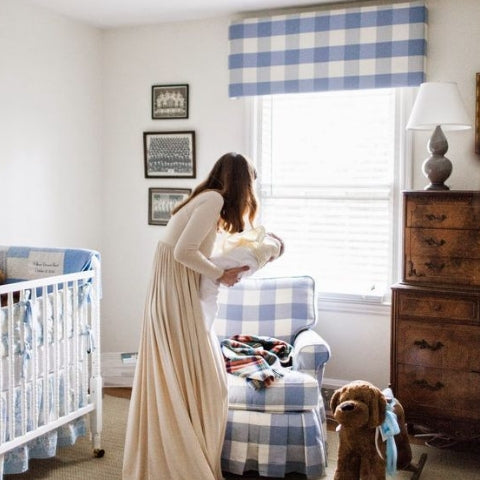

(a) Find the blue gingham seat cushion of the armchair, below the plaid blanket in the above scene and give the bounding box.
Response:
[227,370,319,413]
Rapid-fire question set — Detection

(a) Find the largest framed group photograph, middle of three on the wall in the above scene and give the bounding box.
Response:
[143,131,196,178]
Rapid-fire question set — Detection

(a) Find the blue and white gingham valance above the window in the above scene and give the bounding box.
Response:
[228,1,427,97]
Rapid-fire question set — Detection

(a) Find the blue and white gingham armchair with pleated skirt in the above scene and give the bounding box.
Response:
[214,276,330,479]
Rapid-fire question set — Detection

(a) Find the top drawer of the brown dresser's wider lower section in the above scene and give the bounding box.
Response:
[395,290,480,322]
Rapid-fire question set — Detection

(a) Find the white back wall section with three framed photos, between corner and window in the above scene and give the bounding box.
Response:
[102,19,246,351]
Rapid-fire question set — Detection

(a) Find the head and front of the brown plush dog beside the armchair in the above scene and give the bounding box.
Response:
[330,380,387,480]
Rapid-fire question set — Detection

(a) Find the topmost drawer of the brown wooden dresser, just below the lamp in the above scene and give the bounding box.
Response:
[405,193,480,230]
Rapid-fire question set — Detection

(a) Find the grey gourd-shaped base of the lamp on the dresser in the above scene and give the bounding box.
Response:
[422,126,452,190]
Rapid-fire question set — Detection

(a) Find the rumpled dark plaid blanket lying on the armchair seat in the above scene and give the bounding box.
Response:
[221,335,293,390]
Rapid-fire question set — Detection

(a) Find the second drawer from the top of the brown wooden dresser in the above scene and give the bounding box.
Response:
[405,228,480,259]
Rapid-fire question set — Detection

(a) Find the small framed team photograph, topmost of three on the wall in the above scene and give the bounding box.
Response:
[152,85,188,120]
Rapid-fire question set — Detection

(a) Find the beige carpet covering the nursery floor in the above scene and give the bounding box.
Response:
[4,395,480,480]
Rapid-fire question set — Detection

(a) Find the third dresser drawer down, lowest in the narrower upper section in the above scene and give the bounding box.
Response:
[403,252,480,287]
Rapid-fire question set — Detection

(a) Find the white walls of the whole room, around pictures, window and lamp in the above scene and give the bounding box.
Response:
[0,0,480,385]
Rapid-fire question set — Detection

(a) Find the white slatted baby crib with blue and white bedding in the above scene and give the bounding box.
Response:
[0,246,104,479]
